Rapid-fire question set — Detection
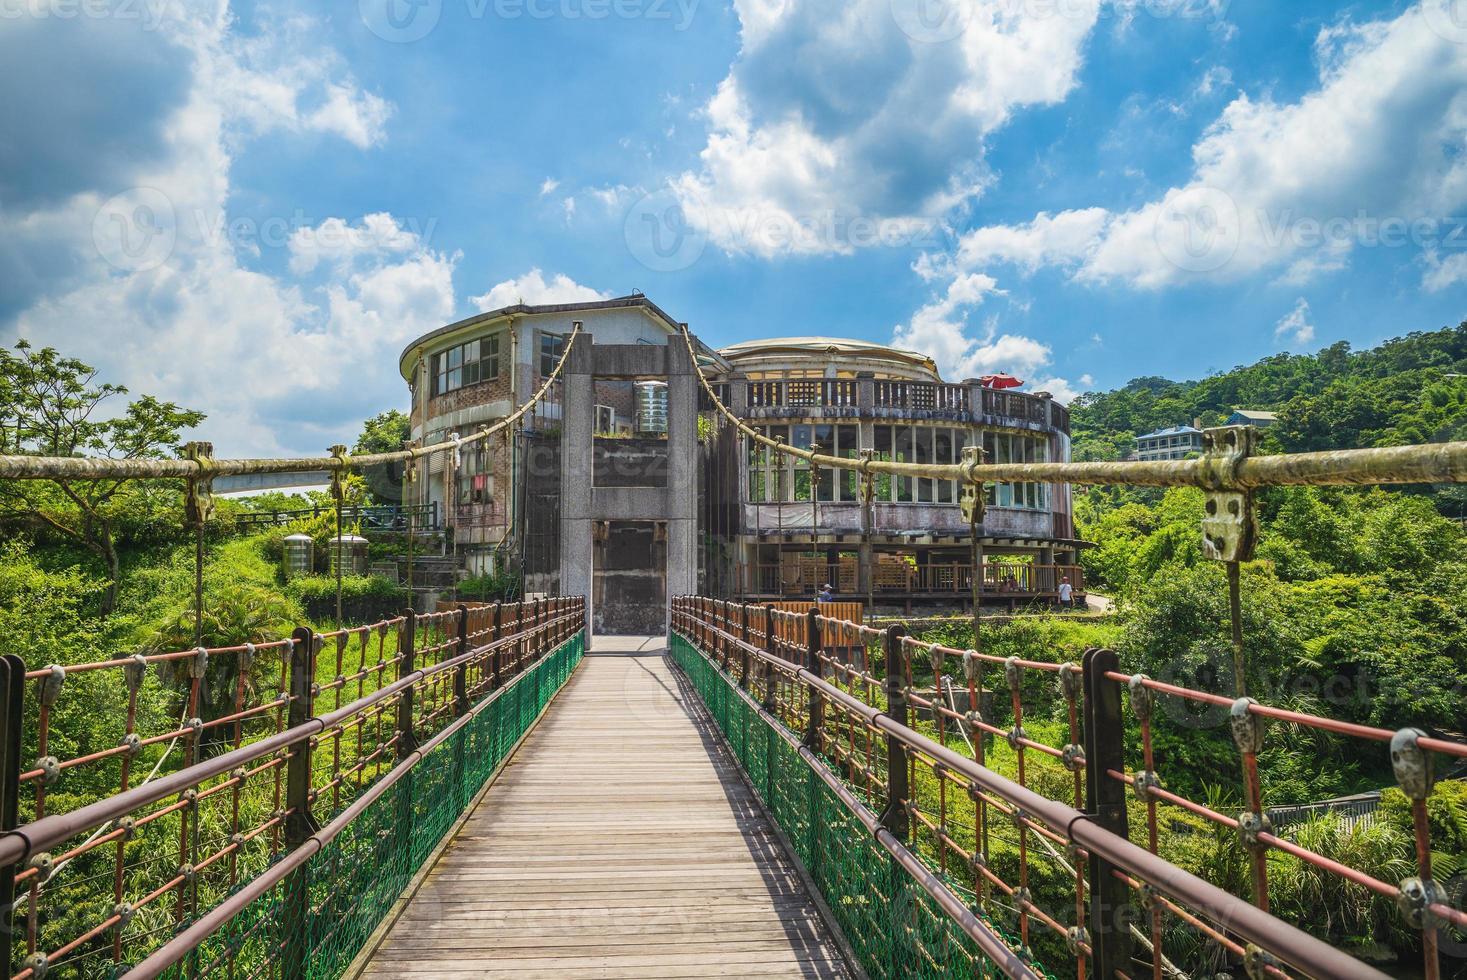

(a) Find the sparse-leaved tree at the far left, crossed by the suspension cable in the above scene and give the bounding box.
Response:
[0,340,205,613]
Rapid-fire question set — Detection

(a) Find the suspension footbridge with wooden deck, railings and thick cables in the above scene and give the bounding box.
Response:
[0,329,1467,980]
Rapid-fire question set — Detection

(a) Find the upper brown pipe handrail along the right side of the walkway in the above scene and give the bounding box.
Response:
[673,597,1385,979]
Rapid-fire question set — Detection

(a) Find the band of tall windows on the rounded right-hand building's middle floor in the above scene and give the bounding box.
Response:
[747,424,1049,511]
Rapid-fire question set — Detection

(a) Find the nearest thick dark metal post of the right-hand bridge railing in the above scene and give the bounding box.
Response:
[1081,648,1131,977]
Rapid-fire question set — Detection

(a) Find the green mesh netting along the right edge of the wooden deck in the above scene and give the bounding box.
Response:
[672,634,1037,980]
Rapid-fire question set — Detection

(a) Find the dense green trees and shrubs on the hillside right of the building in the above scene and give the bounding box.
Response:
[897,324,1467,976]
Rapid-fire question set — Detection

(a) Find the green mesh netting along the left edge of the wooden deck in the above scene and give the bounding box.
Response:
[164,634,585,980]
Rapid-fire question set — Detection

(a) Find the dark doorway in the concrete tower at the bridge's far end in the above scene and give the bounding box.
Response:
[591,521,667,637]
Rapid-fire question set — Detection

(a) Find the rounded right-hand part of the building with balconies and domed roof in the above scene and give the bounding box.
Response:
[704,337,1084,606]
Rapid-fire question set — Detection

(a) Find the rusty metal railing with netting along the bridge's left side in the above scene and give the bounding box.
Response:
[0,597,585,980]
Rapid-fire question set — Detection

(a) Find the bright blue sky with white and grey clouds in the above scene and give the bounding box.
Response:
[0,0,1467,455]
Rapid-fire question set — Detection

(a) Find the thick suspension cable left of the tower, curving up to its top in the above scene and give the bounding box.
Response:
[0,320,581,480]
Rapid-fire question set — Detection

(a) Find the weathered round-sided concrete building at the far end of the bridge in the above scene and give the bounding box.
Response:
[399,293,1084,632]
